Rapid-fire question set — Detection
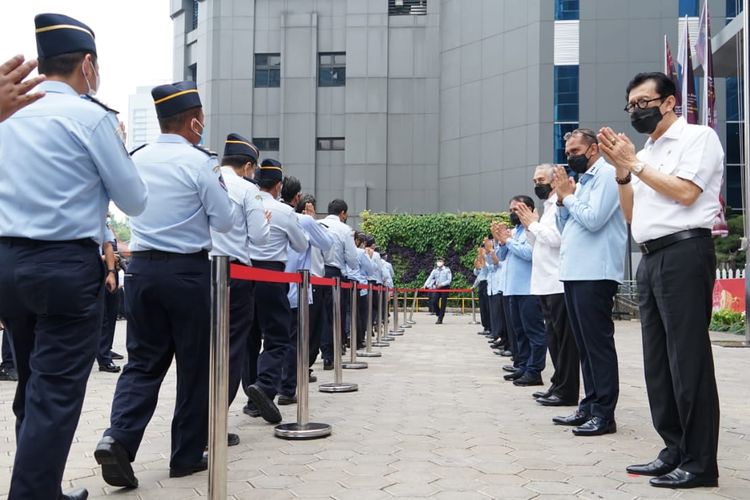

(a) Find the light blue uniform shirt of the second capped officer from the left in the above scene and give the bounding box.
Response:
[130,134,233,254]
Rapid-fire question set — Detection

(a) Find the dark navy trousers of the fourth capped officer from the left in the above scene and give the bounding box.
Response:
[248,261,291,399]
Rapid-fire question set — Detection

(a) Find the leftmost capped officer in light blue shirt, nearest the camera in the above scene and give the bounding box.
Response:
[0,14,147,500]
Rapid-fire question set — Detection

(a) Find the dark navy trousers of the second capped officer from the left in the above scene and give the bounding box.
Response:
[104,252,211,468]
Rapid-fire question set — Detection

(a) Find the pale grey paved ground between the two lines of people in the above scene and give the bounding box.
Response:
[0,314,750,500]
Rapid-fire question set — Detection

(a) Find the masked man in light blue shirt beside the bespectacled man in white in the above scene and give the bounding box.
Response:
[552,128,627,436]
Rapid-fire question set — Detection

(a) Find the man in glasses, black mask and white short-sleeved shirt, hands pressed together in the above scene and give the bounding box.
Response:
[599,73,724,488]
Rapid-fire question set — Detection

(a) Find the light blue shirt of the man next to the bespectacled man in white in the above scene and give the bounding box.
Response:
[557,158,628,282]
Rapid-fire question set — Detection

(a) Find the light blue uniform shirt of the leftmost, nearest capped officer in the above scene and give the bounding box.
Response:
[0,81,147,245]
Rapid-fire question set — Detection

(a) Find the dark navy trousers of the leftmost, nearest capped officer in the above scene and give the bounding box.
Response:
[0,238,104,500]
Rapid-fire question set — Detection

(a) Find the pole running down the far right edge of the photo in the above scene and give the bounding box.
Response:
[737,0,750,346]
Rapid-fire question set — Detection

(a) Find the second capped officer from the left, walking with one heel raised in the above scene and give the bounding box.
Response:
[94,82,233,488]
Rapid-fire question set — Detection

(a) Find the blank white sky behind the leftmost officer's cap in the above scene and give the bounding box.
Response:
[0,0,173,121]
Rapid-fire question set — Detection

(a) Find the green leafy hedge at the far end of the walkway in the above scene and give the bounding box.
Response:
[361,211,508,288]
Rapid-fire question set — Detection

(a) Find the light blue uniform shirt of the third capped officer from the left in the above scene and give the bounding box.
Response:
[211,167,271,265]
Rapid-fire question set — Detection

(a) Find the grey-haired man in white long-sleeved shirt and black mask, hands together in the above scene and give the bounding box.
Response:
[518,163,580,406]
